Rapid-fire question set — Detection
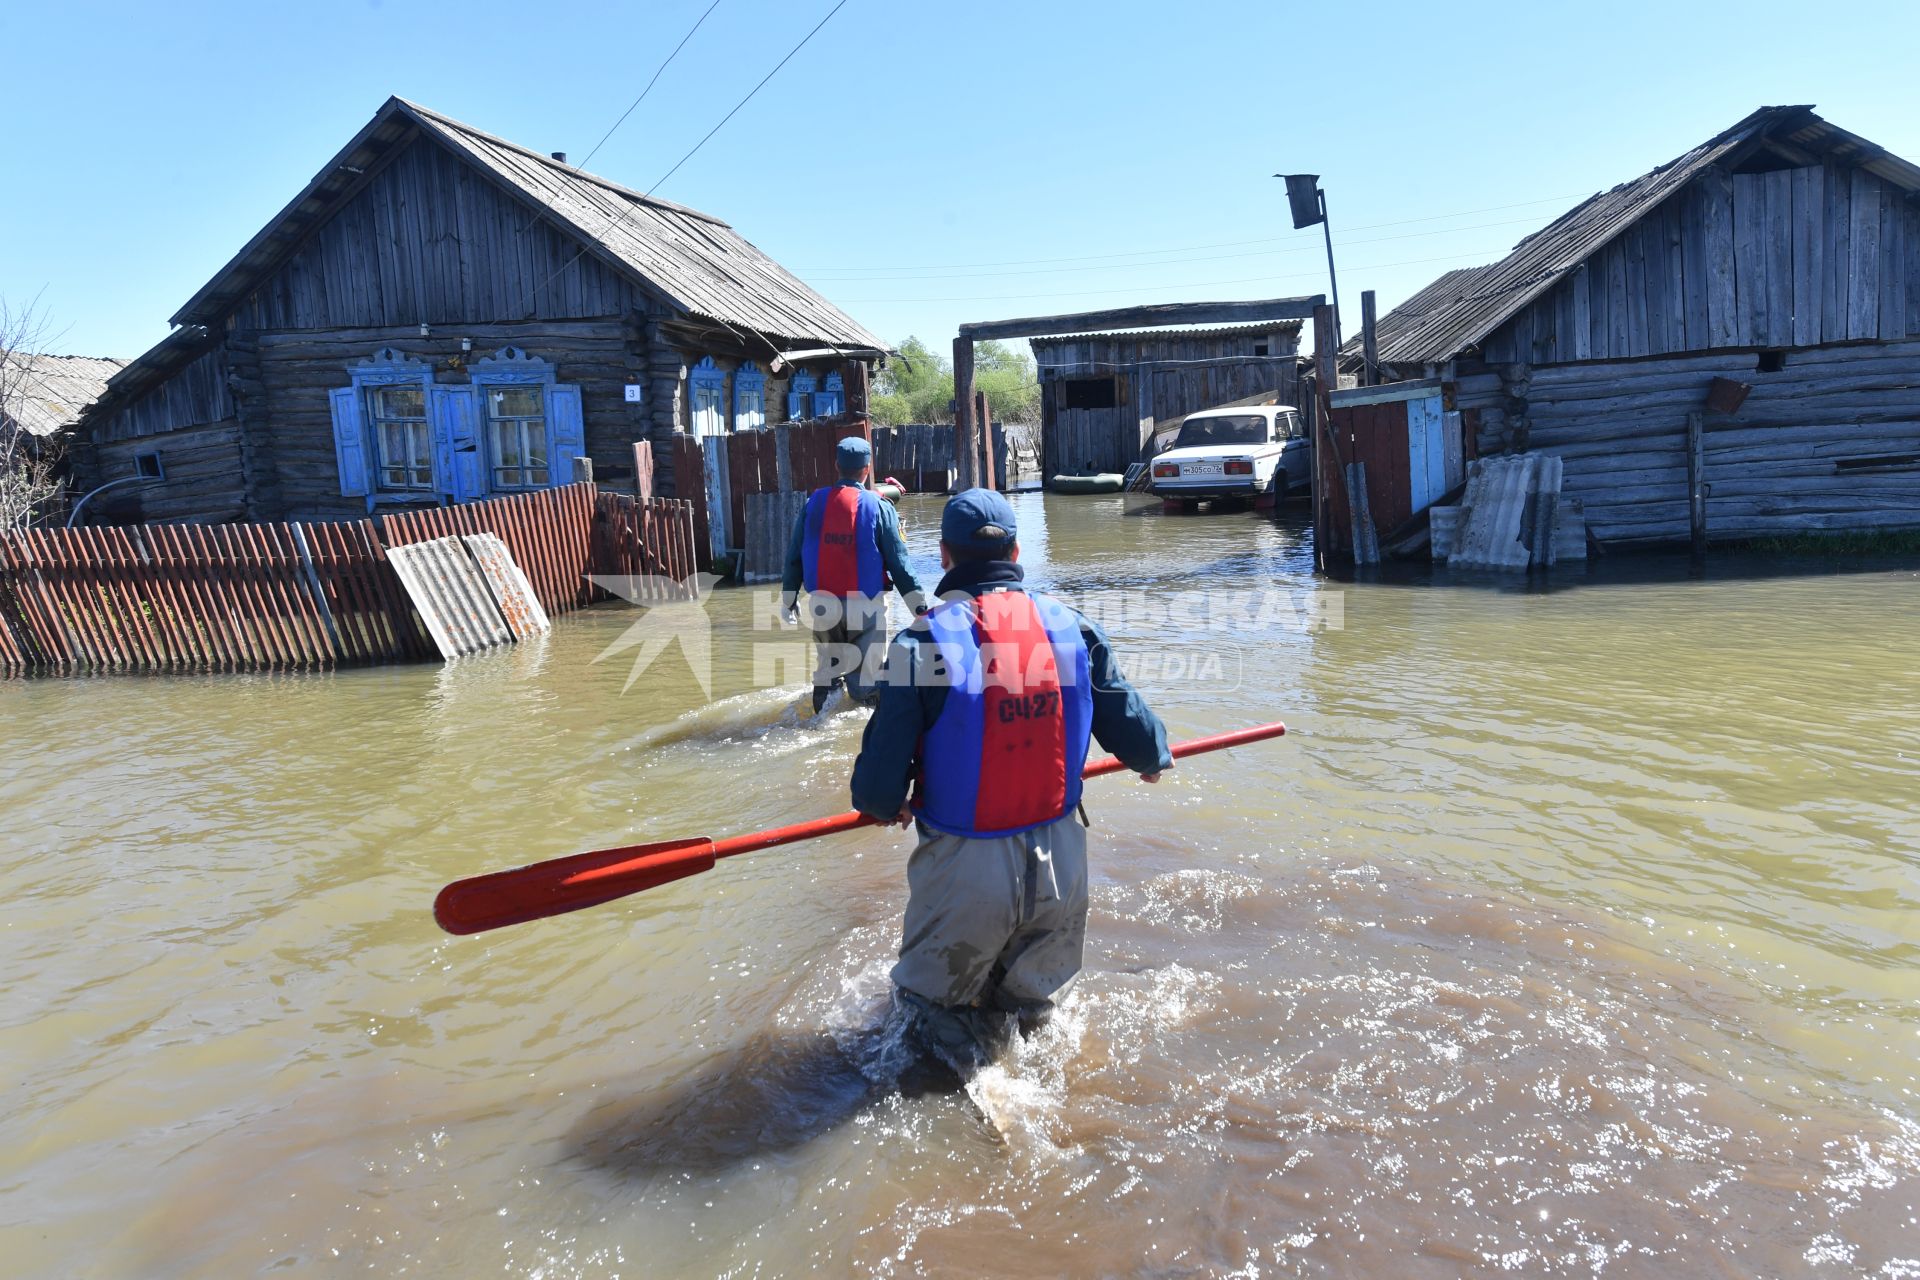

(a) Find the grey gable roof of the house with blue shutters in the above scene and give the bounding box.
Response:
[173,98,885,351]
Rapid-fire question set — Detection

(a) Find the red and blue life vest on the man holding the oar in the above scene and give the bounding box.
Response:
[914,591,1092,837]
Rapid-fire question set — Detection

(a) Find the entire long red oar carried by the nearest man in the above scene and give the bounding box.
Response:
[434,723,1286,933]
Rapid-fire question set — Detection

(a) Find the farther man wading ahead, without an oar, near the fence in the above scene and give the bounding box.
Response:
[780,436,924,714]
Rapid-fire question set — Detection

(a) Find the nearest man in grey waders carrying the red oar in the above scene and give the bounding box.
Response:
[852,489,1173,1073]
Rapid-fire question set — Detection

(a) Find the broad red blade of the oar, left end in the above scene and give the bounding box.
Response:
[434,837,714,933]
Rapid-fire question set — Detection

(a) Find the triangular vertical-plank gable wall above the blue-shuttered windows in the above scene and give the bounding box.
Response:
[230,138,645,334]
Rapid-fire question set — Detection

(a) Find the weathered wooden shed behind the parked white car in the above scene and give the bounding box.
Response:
[1031,320,1300,476]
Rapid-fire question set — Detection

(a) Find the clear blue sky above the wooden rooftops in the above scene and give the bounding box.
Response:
[0,0,1920,355]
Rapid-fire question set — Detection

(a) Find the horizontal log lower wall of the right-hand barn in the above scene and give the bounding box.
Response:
[1480,340,1920,543]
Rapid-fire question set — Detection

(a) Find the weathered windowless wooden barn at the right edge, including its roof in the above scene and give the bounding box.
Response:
[1340,107,1920,545]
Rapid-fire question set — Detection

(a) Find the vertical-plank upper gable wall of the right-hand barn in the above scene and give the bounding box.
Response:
[1482,165,1920,365]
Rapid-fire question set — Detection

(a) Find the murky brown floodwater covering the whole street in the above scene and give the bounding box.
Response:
[0,495,1920,1280]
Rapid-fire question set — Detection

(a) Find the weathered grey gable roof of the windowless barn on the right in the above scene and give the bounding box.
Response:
[1342,106,1920,365]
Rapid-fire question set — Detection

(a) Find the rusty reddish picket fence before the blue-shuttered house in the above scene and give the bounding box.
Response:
[0,484,693,676]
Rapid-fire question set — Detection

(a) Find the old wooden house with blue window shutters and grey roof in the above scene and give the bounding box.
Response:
[77,98,883,520]
